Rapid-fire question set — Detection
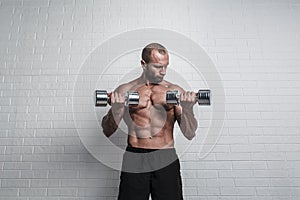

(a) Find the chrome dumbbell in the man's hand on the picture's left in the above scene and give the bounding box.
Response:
[95,90,140,107]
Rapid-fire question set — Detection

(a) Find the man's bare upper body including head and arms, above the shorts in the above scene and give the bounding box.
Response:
[101,46,198,146]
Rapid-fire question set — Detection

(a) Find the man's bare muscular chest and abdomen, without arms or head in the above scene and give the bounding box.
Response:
[120,81,176,149]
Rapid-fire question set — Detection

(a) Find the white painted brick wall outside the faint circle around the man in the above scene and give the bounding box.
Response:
[0,0,300,200]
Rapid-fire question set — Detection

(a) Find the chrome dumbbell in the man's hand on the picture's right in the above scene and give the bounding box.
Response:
[166,90,211,106]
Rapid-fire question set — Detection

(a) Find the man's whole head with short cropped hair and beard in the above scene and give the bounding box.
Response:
[141,43,169,83]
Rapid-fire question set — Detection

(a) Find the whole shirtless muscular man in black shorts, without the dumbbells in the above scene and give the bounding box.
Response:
[102,43,197,200]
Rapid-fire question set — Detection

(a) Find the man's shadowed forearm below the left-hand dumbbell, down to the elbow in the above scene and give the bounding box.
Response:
[101,109,122,137]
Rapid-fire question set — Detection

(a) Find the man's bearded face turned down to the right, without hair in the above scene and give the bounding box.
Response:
[142,50,169,83]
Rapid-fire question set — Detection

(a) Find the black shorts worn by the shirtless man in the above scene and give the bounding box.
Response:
[118,147,183,200]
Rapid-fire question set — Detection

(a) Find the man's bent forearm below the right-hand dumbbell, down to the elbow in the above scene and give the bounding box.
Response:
[178,108,198,140]
